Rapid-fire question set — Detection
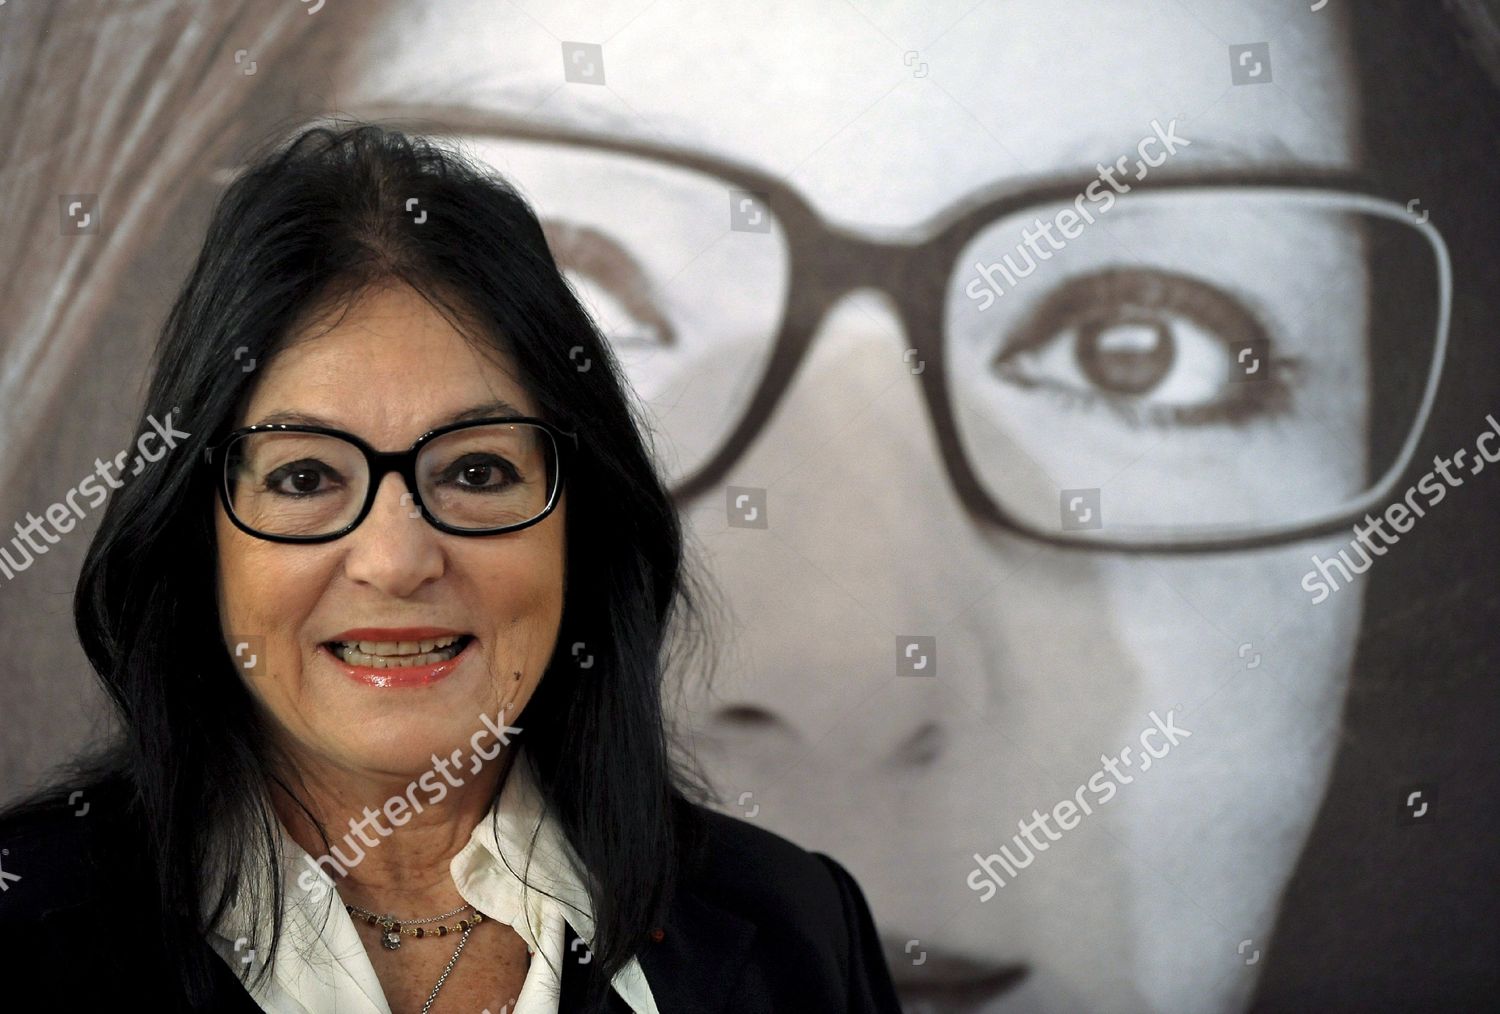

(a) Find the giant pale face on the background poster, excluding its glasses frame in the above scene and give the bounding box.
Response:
[340,0,1364,1011]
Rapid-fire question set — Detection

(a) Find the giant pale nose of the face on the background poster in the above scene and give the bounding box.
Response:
[692,291,1016,768]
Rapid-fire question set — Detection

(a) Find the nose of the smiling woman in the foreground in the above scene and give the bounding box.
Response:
[339,473,443,599]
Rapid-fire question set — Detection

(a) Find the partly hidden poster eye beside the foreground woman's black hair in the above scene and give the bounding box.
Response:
[542,219,677,347]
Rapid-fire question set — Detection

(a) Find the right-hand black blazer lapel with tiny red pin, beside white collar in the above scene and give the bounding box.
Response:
[558,891,756,1014]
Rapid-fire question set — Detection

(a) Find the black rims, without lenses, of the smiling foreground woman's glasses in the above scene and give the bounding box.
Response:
[203,416,581,545]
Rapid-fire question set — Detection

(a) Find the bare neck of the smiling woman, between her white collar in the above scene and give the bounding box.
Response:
[272,746,515,920]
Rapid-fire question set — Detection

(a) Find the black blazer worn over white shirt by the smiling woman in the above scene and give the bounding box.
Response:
[0,792,900,1014]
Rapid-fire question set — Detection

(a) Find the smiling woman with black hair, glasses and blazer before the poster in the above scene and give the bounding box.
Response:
[0,125,897,1014]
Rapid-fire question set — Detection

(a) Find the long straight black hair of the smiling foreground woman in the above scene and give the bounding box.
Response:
[1,120,711,1007]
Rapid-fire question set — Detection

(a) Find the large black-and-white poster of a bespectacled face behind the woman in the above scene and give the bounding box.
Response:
[0,0,1500,1014]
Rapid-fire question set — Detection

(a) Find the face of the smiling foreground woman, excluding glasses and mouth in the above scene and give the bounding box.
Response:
[216,287,564,785]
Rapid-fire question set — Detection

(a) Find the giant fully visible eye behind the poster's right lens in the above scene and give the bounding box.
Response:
[993,269,1293,426]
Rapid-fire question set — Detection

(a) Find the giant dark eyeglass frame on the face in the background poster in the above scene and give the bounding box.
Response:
[270,104,1454,554]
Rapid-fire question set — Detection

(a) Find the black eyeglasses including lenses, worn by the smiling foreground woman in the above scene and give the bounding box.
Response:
[203,416,579,543]
